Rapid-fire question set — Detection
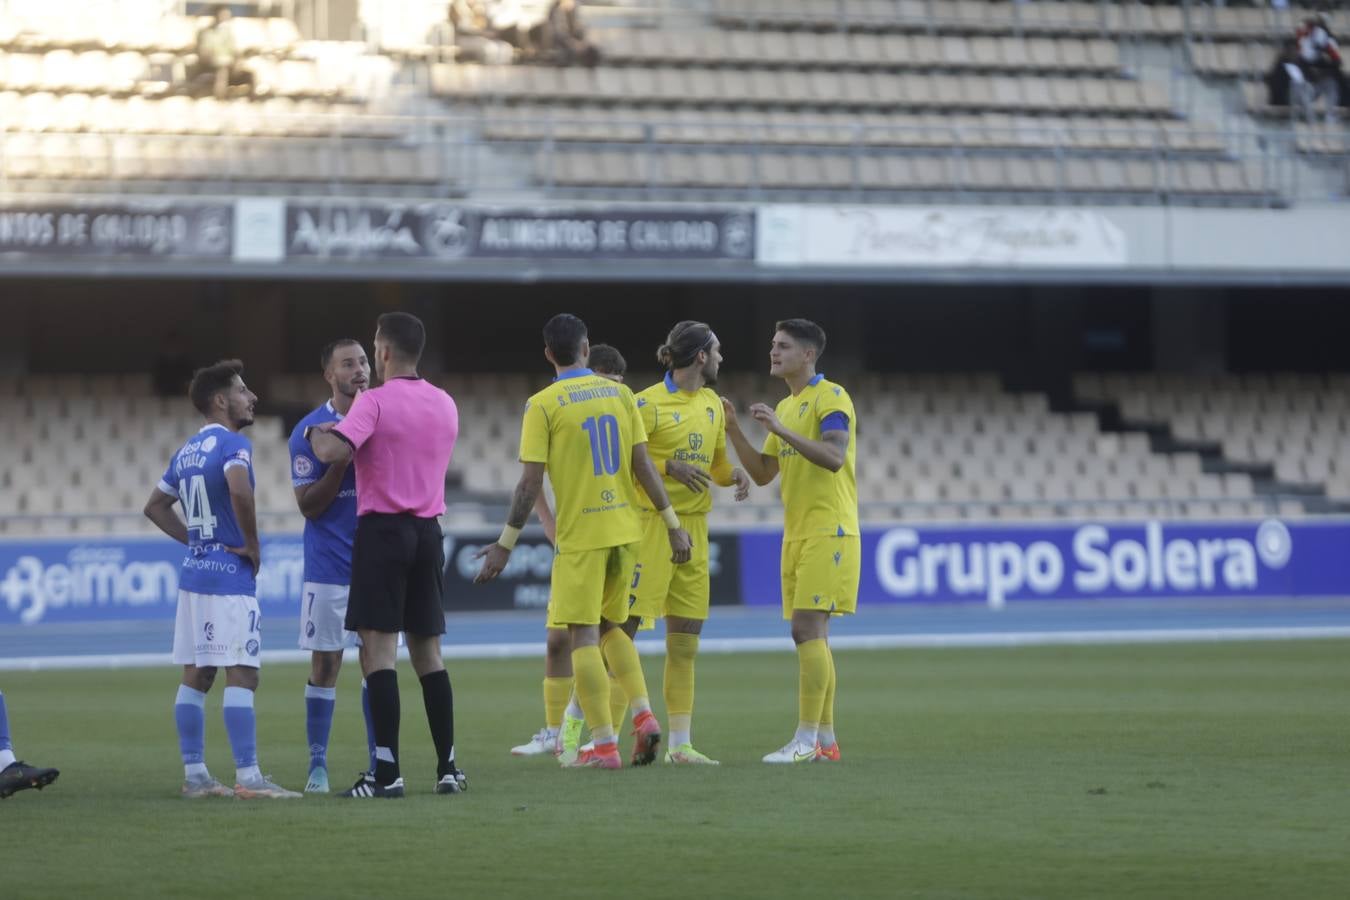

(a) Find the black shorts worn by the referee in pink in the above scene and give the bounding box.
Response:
[346,513,446,634]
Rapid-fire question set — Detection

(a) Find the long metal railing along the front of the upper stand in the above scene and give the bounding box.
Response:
[0,108,1350,204]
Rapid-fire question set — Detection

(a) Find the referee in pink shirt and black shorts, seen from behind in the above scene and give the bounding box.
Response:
[305,313,466,797]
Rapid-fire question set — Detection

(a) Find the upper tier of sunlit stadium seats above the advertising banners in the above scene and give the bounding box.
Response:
[0,0,1328,205]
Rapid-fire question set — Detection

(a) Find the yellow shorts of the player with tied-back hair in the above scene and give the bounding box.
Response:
[628,513,709,626]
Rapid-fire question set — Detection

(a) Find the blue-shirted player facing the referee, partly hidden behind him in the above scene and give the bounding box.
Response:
[290,337,375,793]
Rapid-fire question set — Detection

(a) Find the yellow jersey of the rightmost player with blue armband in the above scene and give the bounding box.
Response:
[761,375,859,541]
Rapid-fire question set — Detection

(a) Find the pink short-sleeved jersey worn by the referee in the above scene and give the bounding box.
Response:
[333,378,459,518]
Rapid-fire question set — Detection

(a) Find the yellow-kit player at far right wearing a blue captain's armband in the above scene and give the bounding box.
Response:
[725,318,863,762]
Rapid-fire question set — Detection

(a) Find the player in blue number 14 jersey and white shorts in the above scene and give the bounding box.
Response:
[144,359,301,799]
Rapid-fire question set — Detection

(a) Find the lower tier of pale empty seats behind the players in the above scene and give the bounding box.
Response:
[0,374,1317,537]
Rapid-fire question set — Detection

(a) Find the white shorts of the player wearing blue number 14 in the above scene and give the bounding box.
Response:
[173,591,262,669]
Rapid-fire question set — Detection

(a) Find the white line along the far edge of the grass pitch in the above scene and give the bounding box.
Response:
[0,625,1350,672]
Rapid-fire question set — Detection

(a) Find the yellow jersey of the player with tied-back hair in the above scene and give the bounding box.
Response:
[637,372,732,515]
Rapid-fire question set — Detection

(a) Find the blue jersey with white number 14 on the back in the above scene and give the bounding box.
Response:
[159,424,257,596]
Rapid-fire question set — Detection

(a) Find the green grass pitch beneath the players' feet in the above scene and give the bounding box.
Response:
[0,641,1350,900]
